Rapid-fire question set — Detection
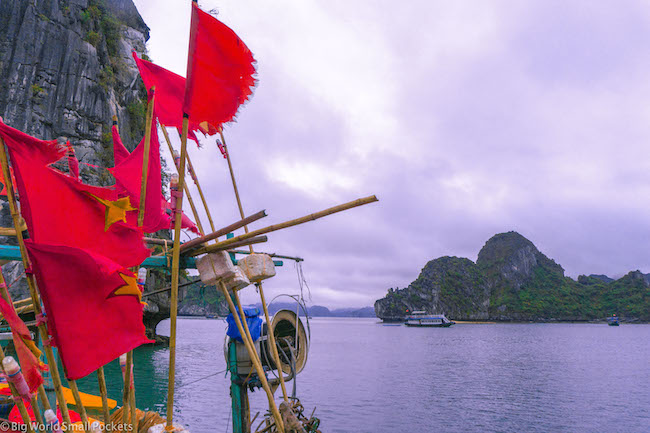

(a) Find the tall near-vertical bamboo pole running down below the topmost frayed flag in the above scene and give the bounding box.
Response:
[167,115,189,429]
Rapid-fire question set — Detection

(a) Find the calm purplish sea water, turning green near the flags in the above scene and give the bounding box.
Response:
[73,318,650,433]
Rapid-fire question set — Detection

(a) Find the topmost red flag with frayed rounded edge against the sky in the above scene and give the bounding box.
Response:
[183,3,256,127]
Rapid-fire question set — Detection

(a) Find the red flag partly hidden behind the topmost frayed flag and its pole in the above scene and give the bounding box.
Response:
[132,51,210,143]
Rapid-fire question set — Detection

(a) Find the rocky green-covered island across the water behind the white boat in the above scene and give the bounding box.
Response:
[375,232,650,322]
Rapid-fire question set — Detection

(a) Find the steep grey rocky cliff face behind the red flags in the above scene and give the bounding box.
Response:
[0,0,169,337]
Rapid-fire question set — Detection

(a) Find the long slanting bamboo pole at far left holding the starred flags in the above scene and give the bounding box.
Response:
[0,137,72,426]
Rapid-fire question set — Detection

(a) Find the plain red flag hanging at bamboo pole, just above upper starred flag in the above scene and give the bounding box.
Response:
[109,103,169,233]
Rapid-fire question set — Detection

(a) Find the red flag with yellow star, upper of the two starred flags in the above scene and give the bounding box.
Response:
[11,149,149,267]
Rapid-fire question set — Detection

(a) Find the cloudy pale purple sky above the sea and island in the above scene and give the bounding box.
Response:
[135,0,650,308]
